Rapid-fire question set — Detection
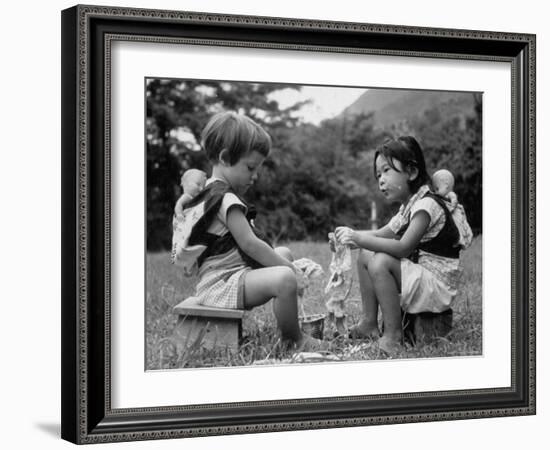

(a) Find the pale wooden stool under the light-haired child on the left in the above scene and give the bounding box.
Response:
[174,297,244,351]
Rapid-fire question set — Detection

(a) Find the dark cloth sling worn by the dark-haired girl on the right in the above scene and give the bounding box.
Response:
[397,192,460,263]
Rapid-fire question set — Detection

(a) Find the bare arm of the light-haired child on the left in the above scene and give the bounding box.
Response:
[227,208,294,268]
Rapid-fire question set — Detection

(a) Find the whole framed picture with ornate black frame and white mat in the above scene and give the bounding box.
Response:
[62,6,535,444]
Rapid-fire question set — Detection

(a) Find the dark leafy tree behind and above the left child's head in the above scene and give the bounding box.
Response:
[146,79,310,250]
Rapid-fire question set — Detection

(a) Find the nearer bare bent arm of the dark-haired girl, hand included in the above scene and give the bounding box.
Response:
[336,210,430,258]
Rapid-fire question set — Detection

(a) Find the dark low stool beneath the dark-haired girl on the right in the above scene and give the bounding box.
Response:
[403,309,453,344]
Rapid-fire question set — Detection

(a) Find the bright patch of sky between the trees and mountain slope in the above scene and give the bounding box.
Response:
[270,86,367,125]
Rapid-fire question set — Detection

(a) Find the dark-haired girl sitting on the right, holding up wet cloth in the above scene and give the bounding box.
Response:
[335,136,470,353]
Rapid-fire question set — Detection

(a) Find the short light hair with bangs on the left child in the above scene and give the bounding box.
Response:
[201,112,271,166]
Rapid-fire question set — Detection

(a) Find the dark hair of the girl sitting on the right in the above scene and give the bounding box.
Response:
[374,136,430,193]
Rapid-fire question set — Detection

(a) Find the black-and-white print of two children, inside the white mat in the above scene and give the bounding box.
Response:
[144,77,484,371]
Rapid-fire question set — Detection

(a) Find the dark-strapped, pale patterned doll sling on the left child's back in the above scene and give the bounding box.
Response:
[172,181,271,276]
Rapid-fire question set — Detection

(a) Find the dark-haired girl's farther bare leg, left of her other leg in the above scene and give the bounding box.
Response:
[350,250,380,338]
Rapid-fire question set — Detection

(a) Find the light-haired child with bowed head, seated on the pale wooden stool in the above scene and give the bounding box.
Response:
[175,112,323,350]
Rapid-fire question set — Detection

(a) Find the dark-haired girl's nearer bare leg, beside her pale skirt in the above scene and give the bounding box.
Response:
[368,253,403,350]
